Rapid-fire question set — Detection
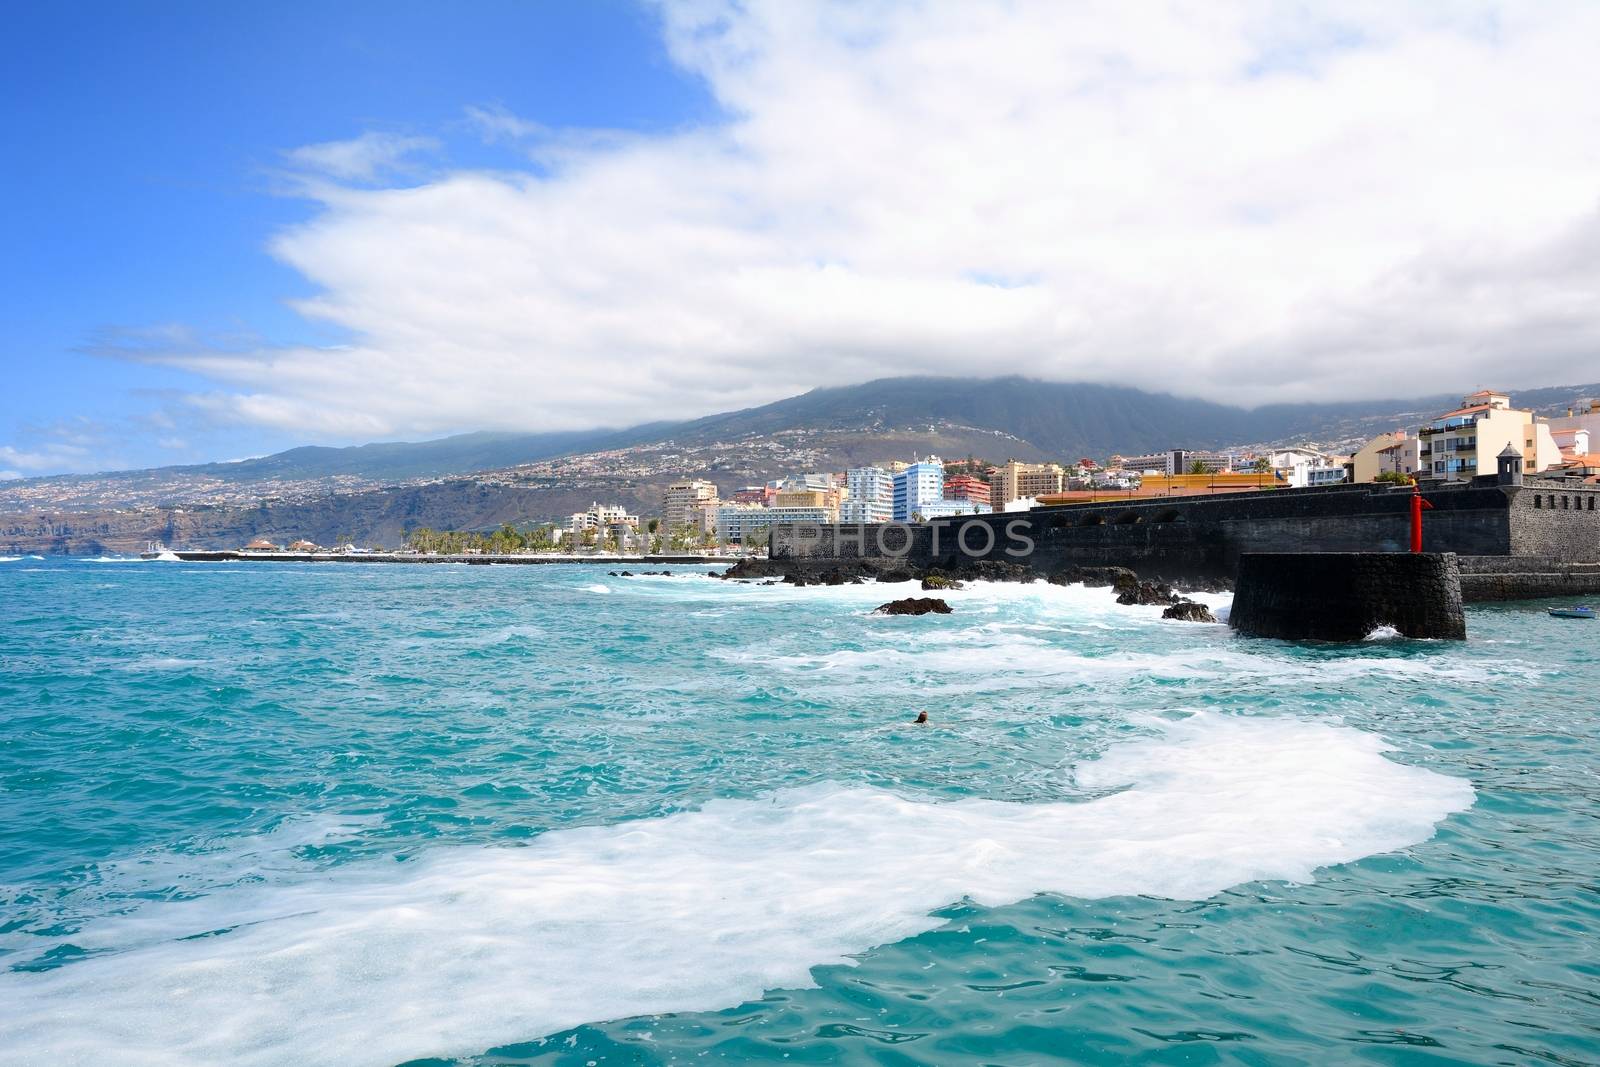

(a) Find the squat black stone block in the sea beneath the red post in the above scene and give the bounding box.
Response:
[1227,552,1467,641]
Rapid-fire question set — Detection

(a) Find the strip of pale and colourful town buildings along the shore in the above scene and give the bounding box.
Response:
[243,390,1600,555]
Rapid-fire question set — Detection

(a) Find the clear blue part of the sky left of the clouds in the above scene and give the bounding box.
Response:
[0,0,712,474]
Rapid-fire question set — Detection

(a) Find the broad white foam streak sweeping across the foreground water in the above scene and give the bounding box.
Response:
[0,713,1474,1065]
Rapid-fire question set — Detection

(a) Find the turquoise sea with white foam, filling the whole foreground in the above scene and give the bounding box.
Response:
[0,558,1600,1067]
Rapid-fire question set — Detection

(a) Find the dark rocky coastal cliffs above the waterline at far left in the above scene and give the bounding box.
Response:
[0,480,661,555]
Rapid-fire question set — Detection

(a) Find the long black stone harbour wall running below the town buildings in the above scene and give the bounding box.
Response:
[766,475,1600,600]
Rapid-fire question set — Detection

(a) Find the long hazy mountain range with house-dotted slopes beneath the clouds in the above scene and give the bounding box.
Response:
[0,376,1600,552]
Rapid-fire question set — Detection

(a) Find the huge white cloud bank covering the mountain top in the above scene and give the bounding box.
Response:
[147,0,1600,437]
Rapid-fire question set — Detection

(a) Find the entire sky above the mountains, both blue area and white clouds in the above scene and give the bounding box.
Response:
[0,0,1600,477]
